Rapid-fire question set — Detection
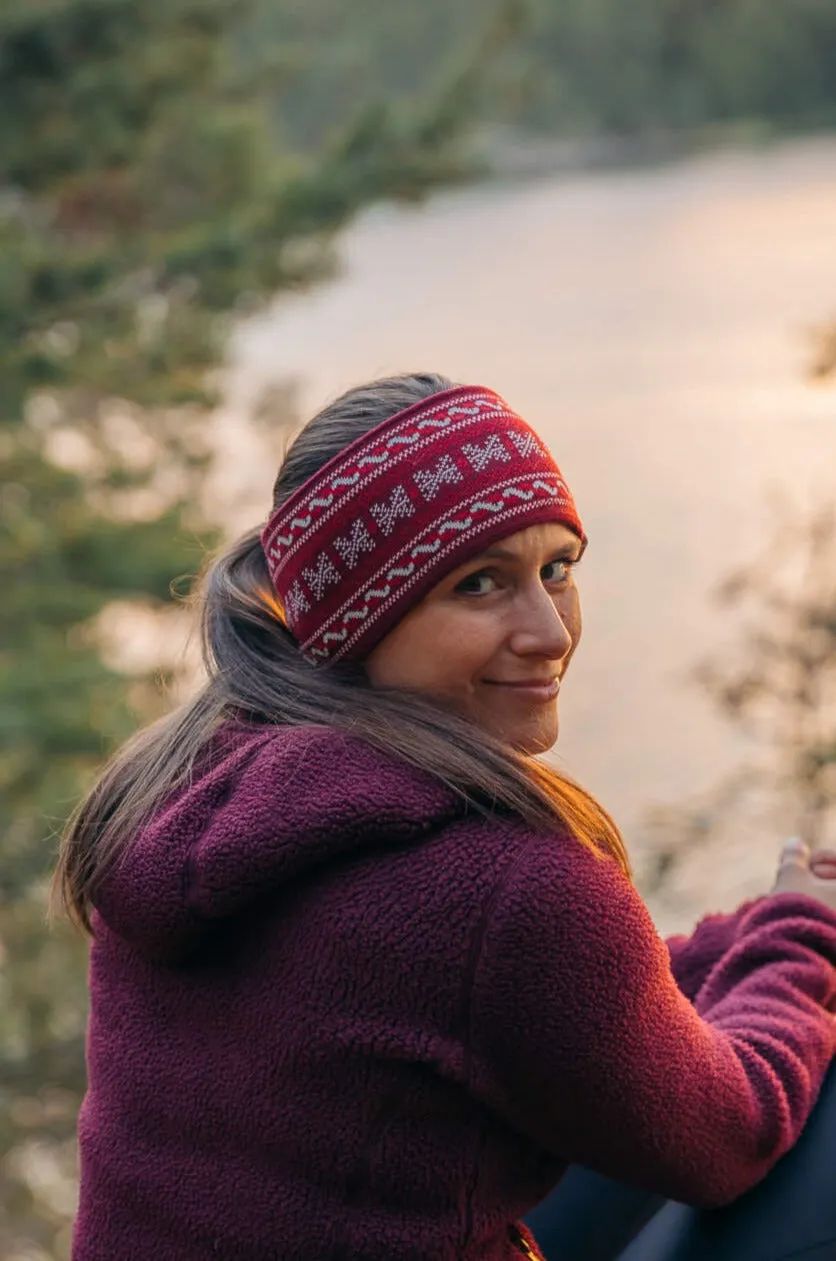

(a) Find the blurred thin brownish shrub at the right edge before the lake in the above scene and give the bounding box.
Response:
[642,497,836,894]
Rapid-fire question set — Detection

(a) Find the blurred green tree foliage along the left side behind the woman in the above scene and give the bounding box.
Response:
[0,0,503,1258]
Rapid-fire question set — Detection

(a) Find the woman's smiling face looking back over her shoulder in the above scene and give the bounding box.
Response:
[366,522,583,754]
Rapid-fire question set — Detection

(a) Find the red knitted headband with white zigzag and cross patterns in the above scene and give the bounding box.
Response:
[261,386,585,663]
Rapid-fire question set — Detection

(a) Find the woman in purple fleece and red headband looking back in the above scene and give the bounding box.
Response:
[59,376,836,1261]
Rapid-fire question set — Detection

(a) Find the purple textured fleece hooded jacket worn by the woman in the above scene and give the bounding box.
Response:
[73,724,836,1261]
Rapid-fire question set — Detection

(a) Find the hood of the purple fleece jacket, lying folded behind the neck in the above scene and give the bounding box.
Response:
[93,721,467,957]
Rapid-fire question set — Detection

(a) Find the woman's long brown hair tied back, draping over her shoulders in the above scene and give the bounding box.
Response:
[54,373,629,931]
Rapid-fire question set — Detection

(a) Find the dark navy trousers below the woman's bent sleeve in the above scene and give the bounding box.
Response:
[528,1068,836,1261]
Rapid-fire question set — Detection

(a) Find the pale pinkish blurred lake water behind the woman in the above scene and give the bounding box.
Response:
[227,139,836,915]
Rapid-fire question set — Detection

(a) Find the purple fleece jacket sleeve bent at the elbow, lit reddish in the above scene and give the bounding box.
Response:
[469,837,836,1207]
